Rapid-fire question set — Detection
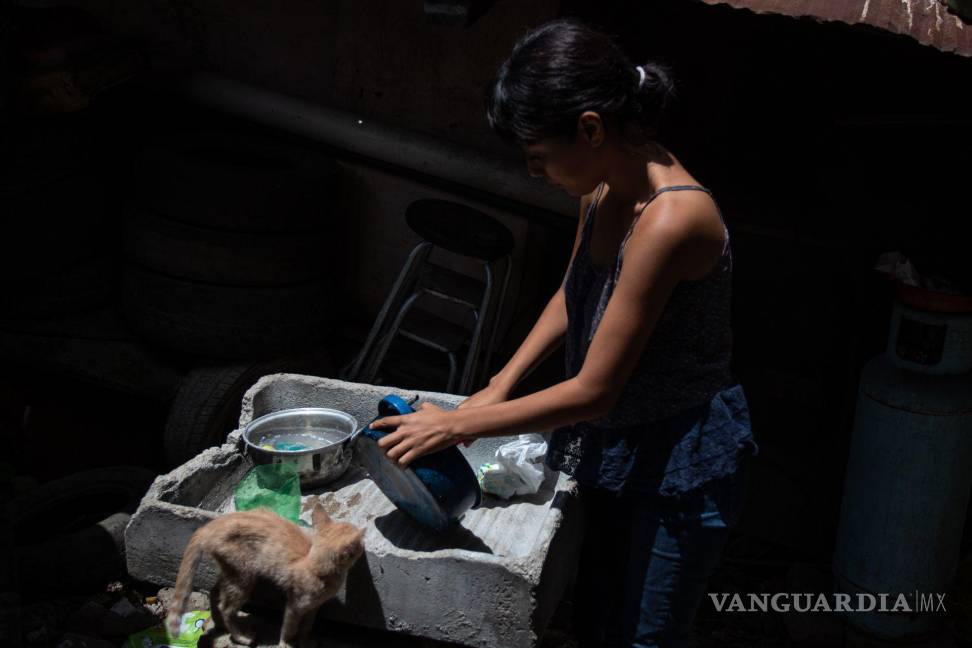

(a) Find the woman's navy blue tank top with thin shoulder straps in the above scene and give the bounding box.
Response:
[547,185,757,495]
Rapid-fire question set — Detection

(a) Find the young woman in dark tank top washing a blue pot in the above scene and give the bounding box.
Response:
[374,20,756,646]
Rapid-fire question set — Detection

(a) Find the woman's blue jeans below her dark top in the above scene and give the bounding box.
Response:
[574,456,750,648]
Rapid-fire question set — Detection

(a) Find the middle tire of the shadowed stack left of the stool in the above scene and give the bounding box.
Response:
[125,209,328,286]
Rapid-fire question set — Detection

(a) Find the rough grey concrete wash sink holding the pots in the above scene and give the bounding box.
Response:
[126,374,581,648]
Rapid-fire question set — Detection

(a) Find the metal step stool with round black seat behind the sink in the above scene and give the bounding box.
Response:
[345,199,513,394]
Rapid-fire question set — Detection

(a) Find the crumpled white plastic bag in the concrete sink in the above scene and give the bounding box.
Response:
[479,434,547,499]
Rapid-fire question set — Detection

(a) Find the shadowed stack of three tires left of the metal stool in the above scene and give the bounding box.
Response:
[123,133,336,359]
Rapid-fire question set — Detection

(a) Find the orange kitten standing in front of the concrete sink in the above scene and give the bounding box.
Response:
[168,503,364,648]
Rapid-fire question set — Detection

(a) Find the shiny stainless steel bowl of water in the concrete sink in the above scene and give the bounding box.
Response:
[240,407,358,486]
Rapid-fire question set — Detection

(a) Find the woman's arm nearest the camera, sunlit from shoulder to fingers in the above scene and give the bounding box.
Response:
[373,197,723,465]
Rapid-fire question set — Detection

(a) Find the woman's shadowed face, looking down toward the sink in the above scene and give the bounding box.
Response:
[522,128,603,196]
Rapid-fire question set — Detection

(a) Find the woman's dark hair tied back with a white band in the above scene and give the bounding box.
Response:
[486,19,674,144]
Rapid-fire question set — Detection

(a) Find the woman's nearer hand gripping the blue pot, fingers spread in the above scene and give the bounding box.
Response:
[371,403,459,468]
